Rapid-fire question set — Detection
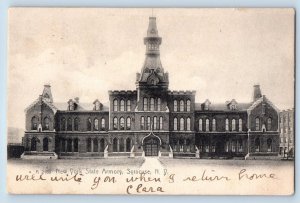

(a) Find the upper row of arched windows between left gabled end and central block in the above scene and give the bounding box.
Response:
[60,117,105,131]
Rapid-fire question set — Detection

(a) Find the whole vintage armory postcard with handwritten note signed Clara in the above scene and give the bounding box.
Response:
[7,8,295,195]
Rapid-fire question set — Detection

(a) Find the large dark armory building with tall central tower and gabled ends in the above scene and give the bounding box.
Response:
[23,17,279,158]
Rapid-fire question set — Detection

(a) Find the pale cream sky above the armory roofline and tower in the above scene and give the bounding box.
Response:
[7,8,294,128]
